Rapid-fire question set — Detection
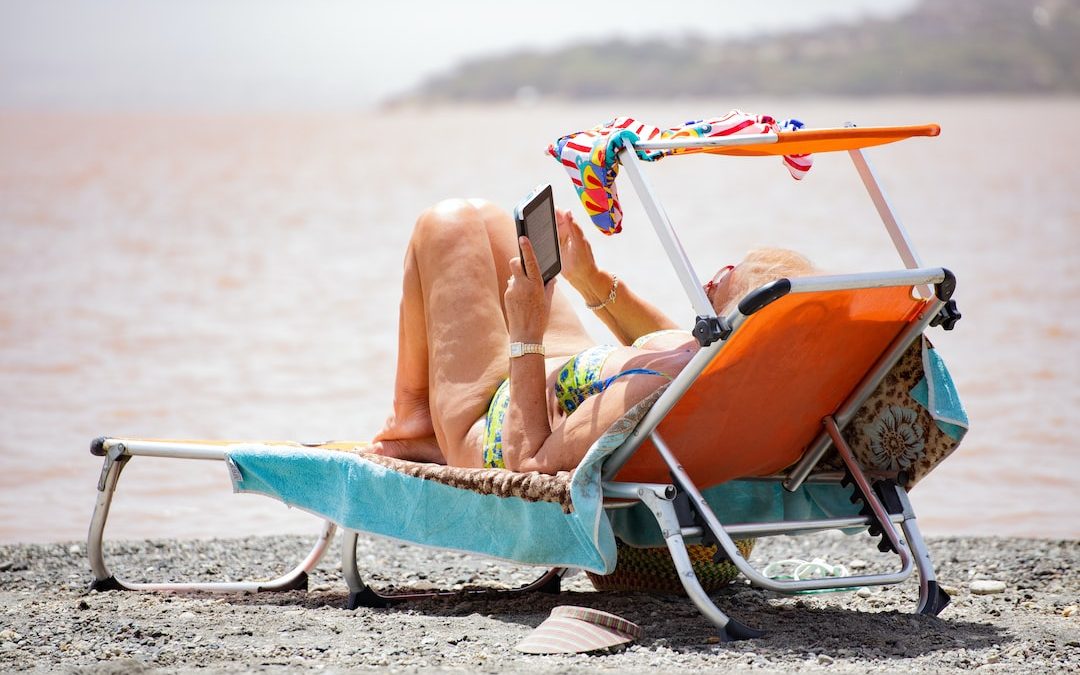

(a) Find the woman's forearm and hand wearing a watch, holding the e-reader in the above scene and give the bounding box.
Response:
[502,237,555,471]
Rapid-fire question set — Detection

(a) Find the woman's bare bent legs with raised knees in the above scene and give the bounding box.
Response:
[374,200,592,465]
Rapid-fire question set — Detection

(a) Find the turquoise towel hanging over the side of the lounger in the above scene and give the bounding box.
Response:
[221,392,855,575]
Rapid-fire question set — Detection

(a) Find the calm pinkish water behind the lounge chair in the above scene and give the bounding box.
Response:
[0,99,1080,542]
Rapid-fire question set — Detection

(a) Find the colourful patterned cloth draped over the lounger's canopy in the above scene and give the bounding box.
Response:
[548,110,813,234]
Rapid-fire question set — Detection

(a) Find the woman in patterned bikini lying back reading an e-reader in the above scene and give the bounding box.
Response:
[370,200,812,473]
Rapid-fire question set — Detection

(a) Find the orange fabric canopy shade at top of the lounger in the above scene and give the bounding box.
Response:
[674,124,942,157]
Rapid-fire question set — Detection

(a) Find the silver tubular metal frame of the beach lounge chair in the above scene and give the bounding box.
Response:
[87,125,958,639]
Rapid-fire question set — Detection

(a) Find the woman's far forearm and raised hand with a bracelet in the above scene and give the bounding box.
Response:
[555,210,678,345]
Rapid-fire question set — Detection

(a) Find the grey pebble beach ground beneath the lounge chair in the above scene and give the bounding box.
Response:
[0,535,1080,673]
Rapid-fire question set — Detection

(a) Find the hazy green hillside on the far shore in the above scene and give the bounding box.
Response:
[392,0,1080,103]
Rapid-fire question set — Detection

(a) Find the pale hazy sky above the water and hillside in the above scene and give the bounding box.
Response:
[0,0,916,110]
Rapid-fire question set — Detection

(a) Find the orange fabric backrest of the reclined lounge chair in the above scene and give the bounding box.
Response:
[616,286,928,487]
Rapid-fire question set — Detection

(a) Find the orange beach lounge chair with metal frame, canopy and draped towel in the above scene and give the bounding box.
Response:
[89,118,967,639]
